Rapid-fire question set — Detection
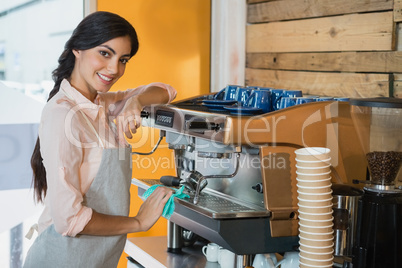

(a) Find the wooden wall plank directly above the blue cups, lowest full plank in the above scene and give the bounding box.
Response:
[246,68,392,98]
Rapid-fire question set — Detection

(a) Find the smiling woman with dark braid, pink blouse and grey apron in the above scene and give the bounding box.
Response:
[24,12,176,267]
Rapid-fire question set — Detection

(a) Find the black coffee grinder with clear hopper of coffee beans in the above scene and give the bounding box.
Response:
[350,98,402,268]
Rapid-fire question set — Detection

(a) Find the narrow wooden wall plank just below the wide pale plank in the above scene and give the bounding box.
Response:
[246,51,402,73]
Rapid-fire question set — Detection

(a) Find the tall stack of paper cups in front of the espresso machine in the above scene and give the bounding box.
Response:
[295,147,334,267]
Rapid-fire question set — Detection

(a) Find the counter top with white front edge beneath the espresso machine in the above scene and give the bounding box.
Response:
[124,236,220,268]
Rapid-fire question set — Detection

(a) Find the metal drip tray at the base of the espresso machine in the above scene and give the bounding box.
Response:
[132,179,271,219]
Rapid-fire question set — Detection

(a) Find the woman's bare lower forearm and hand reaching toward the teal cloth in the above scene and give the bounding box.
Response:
[80,187,173,235]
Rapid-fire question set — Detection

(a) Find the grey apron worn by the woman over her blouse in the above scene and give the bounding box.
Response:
[24,95,132,268]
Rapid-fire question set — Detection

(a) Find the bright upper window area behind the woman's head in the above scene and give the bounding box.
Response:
[0,0,84,101]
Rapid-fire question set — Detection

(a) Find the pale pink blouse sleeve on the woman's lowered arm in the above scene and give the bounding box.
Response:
[39,102,92,236]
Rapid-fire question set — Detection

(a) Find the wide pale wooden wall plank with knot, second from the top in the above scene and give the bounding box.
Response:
[246,12,394,52]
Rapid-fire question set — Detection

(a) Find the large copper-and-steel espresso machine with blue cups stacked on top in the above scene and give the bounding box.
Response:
[132,94,364,265]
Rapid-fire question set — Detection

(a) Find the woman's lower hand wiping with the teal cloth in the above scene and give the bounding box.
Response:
[135,187,173,231]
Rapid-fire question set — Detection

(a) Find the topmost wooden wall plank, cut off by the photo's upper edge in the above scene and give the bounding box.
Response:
[247,0,397,23]
